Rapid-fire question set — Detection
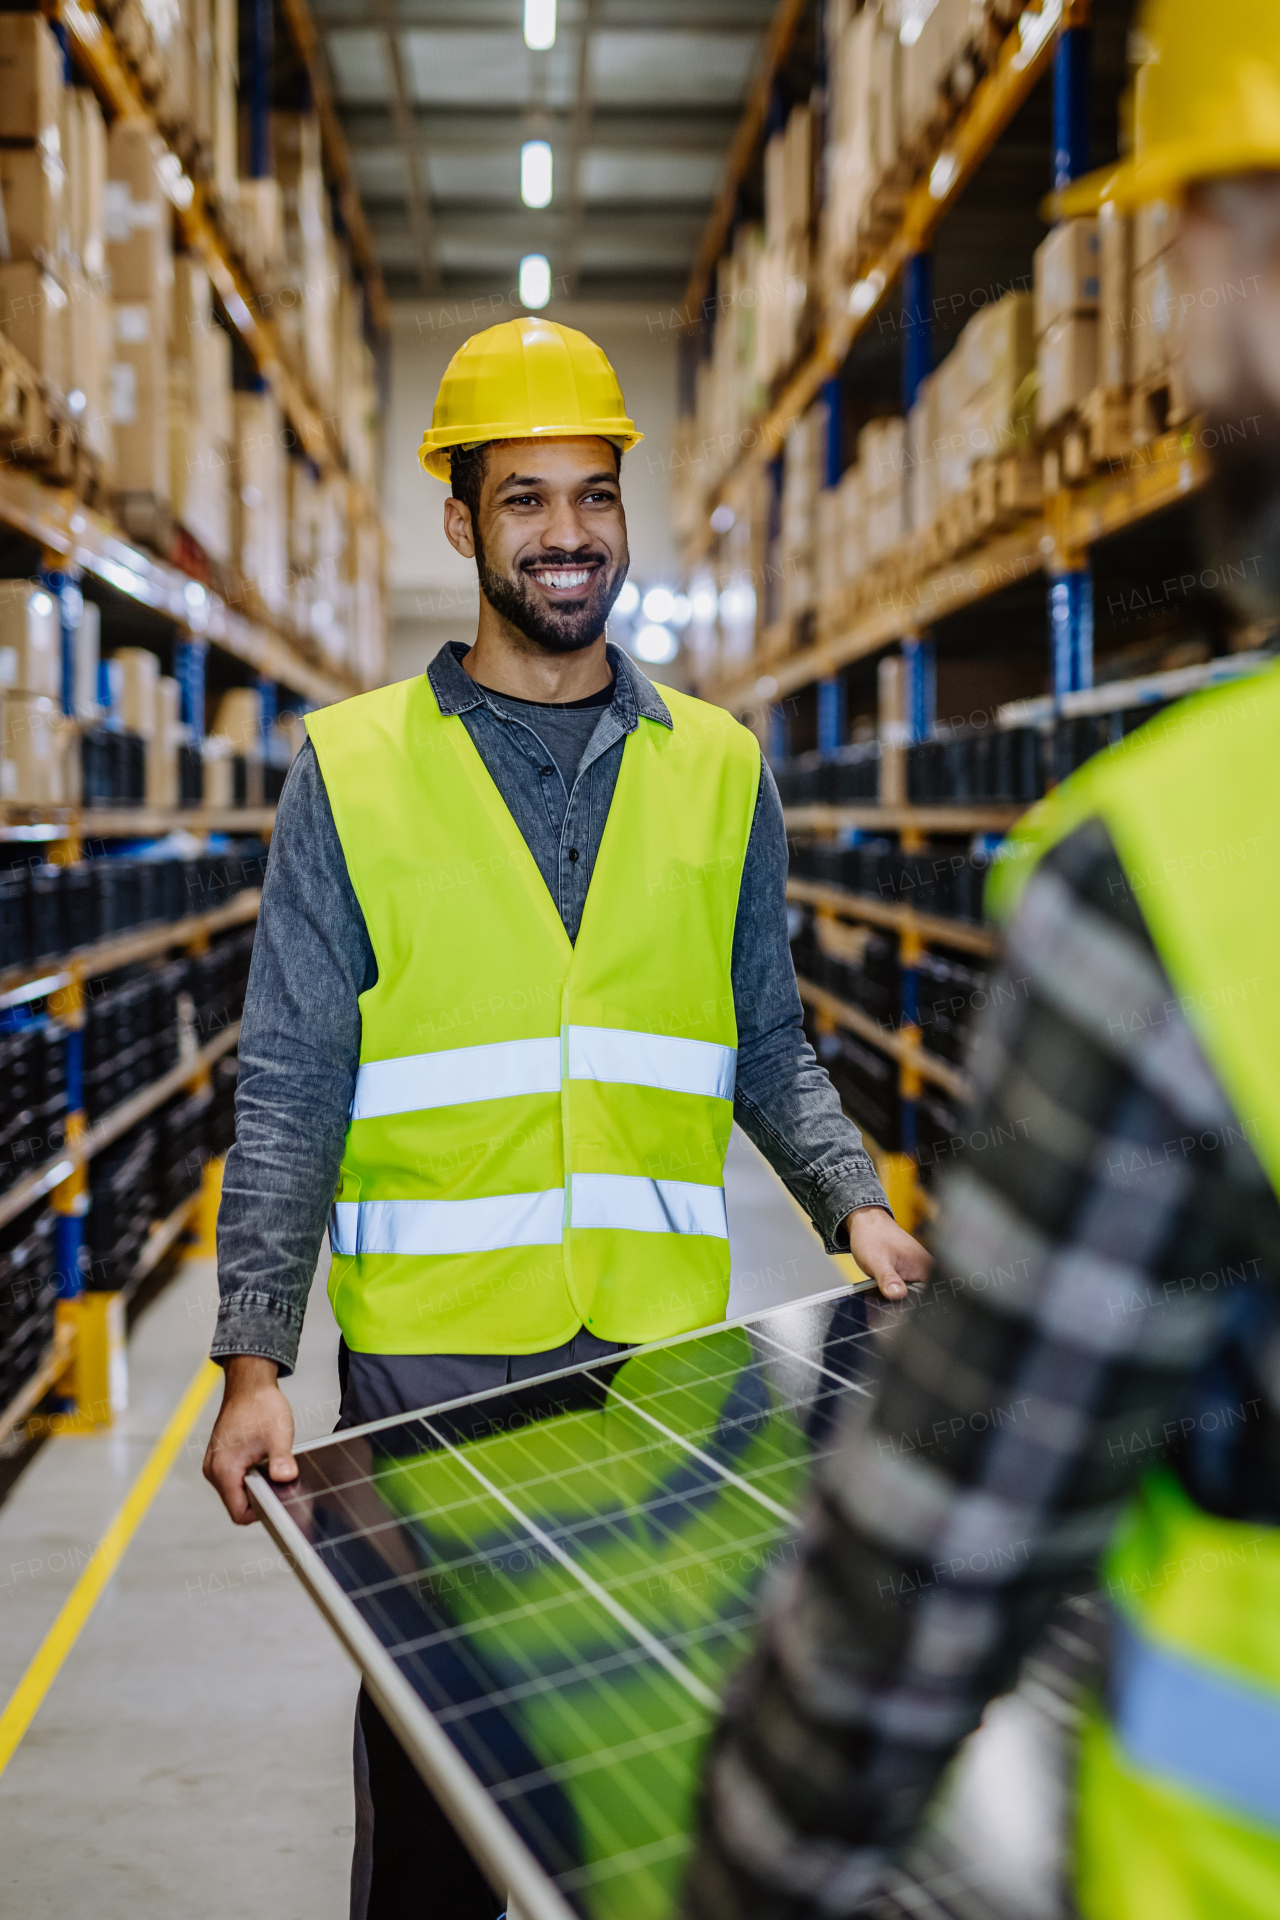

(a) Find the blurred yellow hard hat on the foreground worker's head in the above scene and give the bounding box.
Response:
[1052,0,1280,217]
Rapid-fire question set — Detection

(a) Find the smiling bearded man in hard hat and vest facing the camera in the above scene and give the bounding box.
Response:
[197,319,929,1920]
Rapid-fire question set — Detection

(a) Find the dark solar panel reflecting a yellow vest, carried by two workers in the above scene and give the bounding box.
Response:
[249,1288,871,1920]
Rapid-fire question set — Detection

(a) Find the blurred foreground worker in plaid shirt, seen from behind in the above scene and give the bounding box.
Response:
[685,0,1280,1920]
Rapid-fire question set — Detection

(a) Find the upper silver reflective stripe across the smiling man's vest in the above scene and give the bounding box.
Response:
[351,1027,737,1119]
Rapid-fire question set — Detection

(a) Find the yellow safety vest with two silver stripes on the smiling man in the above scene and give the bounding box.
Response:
[307,676,760,1354]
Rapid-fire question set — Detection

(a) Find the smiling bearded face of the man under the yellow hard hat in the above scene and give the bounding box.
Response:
[449,440,629,653]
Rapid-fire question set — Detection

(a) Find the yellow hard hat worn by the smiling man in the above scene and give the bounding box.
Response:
[418,317,645,480]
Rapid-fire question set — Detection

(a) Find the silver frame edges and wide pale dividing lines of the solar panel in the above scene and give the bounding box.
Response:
[246,1281,875,1920]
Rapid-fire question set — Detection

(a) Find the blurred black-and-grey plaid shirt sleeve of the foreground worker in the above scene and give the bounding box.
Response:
[683,822,1280,1920]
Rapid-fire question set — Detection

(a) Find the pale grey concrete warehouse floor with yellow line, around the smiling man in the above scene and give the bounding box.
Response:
[0,1131,848,1920]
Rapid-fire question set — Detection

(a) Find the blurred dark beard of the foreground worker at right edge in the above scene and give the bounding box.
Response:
[1199,399,1280,622]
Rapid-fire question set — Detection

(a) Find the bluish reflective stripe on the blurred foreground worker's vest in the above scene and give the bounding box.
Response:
[1111,1617,1280,1828]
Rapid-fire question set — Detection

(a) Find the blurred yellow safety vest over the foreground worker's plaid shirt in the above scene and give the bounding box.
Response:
[990,668,1280,1920]
